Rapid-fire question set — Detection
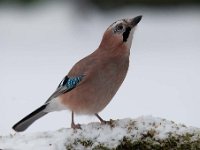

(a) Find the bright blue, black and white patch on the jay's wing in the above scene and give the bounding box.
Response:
[58,76,83,90]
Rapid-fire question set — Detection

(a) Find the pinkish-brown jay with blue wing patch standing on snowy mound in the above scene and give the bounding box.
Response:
[12,15,142,132]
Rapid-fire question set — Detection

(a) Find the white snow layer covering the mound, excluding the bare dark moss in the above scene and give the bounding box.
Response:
[0,116,200,150]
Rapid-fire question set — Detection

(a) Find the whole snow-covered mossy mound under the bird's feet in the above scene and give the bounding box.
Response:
[0,116,200,150]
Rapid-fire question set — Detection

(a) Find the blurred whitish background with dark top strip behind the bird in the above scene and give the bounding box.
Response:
[0,0,200,135]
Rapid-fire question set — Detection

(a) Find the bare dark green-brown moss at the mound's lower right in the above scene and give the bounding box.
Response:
[116,134,200,150]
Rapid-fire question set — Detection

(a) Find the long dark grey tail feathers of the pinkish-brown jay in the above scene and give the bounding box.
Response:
[12,104,48,132]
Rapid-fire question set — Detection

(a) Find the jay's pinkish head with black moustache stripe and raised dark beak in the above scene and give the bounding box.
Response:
[100,16,142,49]
